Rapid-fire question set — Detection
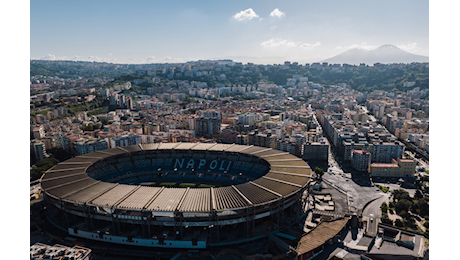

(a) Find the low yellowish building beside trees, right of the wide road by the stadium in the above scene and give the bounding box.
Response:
[369,159,417,177]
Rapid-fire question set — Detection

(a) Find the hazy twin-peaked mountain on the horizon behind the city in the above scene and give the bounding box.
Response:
[320,44,429,65]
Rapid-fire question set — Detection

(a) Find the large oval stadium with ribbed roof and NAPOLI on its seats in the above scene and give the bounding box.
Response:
[41,142,311,248]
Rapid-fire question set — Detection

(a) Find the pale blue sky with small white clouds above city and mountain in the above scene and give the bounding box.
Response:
[30,0,429,64]
